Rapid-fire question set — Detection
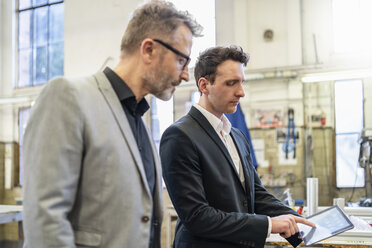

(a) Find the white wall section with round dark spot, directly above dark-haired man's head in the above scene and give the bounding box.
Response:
[216,0,302,69]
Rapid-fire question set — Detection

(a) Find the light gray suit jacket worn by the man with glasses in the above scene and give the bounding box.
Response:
[23,72,163,248]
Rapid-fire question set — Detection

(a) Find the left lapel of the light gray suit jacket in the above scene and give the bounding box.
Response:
[94,72,151,196]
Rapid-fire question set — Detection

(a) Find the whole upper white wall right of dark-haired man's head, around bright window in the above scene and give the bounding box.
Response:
[216,0,372,70]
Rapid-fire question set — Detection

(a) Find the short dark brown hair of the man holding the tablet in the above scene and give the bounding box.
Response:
[194,46,249,89]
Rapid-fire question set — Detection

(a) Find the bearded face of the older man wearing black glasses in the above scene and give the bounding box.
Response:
[147,25,192,100]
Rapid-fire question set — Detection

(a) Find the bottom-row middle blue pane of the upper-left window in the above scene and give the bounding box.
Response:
[34,46,48,85]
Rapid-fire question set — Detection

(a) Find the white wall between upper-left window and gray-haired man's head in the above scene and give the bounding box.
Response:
[65,0,143,76]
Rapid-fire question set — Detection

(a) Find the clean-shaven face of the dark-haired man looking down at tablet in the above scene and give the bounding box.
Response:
[206,60,245,118]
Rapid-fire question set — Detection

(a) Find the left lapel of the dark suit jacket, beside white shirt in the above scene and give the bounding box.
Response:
[189,107,244,186]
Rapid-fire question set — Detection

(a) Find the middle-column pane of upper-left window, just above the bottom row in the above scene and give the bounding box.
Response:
[34,7,48,46]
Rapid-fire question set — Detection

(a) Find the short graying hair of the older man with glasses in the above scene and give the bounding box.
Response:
[121,0,203,54]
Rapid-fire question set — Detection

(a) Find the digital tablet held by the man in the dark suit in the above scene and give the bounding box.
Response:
[297,206,354,246]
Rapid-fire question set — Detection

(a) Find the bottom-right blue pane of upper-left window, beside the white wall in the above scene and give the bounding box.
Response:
[49,42,64,79]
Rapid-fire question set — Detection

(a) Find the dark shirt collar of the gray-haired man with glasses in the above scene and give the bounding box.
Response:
[103,67,150,116]
